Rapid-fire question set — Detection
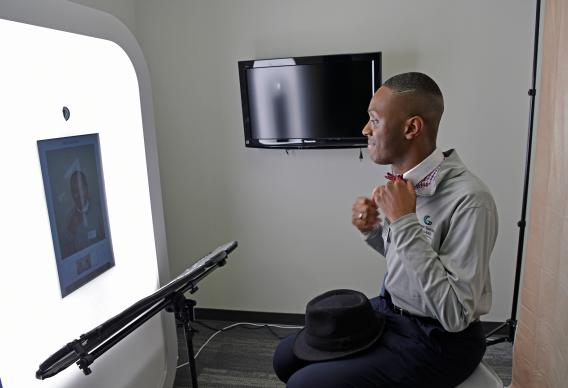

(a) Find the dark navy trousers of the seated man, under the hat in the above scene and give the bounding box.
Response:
[273,297,485,388]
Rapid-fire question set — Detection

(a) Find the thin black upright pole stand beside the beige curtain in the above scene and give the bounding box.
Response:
[486,0,541,346]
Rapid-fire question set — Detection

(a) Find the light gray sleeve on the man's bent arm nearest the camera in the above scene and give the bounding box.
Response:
[390,206,497,332]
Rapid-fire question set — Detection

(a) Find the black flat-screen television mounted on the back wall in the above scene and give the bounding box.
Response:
[238,52,381,149]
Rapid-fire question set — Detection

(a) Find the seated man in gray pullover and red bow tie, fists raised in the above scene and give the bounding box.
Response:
[274,73,498,388]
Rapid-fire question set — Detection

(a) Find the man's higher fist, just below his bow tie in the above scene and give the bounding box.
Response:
[373,178,416,222]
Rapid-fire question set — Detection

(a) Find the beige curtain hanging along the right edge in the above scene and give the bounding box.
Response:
[511,0,568,388]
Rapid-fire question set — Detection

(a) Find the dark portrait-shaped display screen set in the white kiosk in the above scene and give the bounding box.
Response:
[37,134,114,297]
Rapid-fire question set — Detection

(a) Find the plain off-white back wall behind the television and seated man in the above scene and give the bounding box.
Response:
[73,0,534,321]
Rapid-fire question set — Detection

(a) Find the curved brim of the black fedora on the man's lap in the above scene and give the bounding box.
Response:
[292,311,386,361]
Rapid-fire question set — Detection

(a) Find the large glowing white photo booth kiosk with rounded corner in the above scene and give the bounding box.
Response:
[0,0,177,388]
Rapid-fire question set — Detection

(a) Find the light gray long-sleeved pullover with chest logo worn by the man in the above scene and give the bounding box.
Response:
[365,150,498,332]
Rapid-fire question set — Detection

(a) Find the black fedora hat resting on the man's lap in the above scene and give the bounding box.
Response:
[293,290,385,361]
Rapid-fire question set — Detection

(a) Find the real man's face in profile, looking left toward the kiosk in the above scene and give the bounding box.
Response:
[362,86,407,164]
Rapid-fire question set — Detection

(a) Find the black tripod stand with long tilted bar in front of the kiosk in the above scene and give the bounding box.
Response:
[36,241,237,388]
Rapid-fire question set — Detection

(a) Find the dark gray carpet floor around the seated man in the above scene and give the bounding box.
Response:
[174,321,512,388]
